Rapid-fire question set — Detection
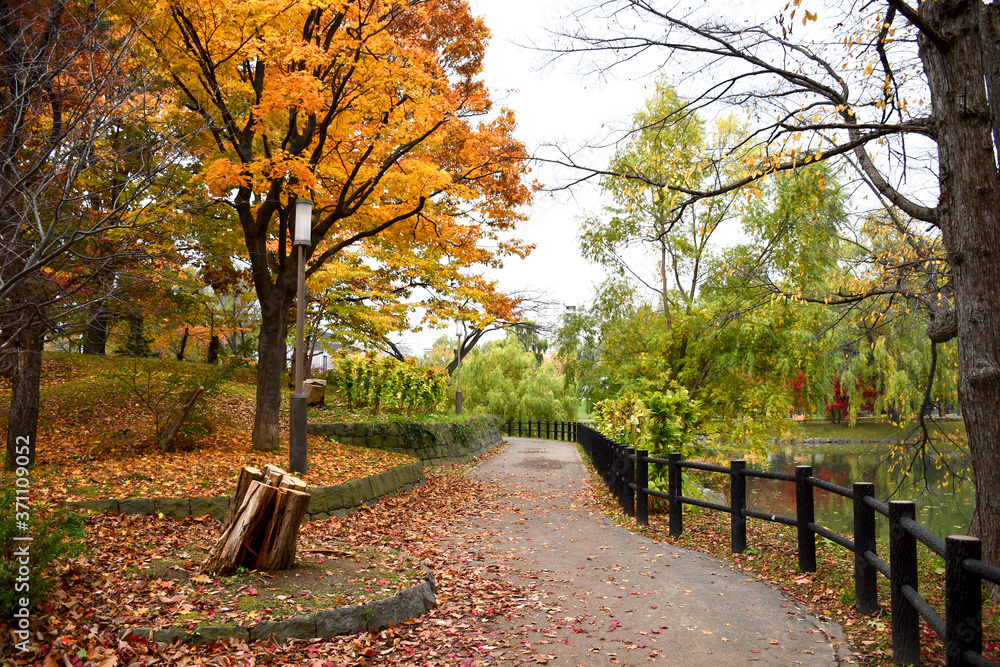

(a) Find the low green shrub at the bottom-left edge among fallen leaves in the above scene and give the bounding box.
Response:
[0,478,84,619]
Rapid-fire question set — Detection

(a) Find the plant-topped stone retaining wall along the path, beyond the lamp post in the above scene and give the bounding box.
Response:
[309,415,503,465]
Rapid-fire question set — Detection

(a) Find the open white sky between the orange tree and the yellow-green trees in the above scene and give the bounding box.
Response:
[403,0,651,355]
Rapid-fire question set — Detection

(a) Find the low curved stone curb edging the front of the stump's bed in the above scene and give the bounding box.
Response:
[118,557,437,646]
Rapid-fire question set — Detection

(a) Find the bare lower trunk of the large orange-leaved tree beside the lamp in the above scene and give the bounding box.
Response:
[252,290,290,452]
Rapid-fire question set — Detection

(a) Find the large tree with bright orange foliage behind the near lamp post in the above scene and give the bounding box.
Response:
[136,0,530,450]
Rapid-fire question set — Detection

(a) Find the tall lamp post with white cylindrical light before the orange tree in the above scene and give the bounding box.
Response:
[288,197,312,475]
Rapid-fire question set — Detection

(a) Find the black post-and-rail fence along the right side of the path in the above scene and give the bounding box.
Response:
[577,424,1000,667]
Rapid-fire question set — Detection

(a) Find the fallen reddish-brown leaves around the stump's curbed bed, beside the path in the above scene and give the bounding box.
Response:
[0,460,531,667]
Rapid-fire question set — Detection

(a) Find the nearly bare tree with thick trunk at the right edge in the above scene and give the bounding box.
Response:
[559,0,1000,562]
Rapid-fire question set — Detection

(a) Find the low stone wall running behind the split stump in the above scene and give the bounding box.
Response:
[70,461,424,521]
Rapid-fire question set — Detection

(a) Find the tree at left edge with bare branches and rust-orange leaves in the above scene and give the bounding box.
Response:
[0,0,188,465]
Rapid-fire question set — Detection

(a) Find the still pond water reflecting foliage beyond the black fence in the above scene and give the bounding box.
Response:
[747,443,975,537]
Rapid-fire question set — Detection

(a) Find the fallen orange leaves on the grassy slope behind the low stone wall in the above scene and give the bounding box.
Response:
[0,353,415,503]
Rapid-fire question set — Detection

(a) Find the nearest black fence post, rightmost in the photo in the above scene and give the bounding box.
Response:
[944,535,983,667]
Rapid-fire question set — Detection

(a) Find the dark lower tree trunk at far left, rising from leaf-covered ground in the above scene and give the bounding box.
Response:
[7,324,45,470]
